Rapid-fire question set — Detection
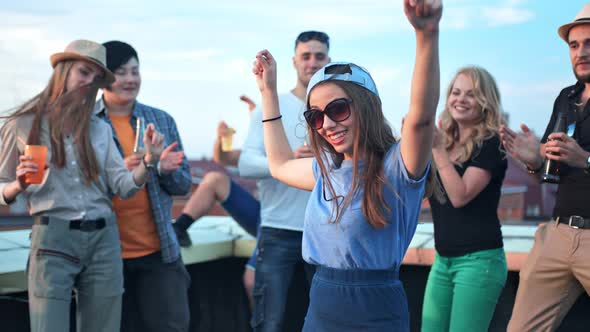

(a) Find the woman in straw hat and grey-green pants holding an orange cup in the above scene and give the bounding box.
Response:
[0,40,163,332]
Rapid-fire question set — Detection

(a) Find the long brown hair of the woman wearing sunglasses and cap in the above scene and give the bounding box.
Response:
[308,80,397,228]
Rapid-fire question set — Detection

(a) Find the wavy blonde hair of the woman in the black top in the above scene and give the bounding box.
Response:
[440,66,504,163]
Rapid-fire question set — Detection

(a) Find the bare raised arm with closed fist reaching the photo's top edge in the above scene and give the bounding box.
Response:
[401,0,442,178]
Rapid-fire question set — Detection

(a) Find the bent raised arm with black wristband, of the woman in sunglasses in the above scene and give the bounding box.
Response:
[252,50,315,190]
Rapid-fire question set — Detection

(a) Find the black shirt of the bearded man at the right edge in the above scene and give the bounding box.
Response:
[541,82,590,218]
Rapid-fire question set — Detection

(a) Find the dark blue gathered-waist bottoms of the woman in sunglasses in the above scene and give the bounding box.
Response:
[303,266,410,332]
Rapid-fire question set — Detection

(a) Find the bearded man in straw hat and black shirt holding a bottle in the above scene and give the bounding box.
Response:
[502,3,590,332]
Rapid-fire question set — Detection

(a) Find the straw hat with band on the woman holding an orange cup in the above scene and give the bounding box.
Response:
[49,39,115,86]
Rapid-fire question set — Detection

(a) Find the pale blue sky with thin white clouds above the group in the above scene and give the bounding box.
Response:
[0,0,584,158]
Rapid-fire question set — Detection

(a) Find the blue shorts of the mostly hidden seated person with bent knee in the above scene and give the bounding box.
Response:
[221,179,260,269]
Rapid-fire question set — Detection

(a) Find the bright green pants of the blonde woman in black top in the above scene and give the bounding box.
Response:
[422,248,508,332]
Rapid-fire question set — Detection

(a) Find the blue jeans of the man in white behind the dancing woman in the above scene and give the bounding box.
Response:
[250,227,314,332]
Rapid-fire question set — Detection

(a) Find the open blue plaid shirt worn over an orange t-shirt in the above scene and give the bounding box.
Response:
[94,98,192,263]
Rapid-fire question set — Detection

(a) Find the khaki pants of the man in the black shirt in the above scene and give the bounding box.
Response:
[508,222,590,332]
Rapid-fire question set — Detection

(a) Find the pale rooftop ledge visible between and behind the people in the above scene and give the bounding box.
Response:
[0,216,537,294]
